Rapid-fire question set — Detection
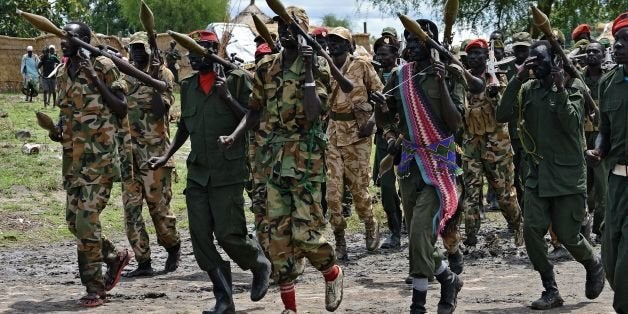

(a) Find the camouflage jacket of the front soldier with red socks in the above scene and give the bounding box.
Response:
[249,53,331,182]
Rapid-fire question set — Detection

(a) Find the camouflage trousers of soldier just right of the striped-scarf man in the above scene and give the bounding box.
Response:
[462,126,521,242]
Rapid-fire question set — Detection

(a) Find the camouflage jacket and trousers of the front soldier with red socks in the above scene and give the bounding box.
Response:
[249,53,336,283]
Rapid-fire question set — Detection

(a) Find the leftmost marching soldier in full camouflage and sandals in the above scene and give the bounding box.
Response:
[50,22,130,307]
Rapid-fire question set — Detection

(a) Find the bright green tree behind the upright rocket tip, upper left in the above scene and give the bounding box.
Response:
[120,0,229,33]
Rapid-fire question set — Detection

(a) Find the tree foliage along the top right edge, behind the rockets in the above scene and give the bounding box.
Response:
[359,0,628,37]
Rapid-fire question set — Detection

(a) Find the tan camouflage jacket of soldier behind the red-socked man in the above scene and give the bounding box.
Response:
[327,56,384,146]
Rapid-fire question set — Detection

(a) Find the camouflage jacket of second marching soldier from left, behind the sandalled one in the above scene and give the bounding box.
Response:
[122,65,174,169]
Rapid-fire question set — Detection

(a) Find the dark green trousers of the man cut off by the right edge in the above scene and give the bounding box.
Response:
[602,174,628,313]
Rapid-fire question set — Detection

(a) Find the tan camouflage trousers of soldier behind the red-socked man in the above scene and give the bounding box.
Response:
[326,137,374,230]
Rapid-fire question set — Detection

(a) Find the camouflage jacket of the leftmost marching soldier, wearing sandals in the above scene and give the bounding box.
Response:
[57,56,125,189]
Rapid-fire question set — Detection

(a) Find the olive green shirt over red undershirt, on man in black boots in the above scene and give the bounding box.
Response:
[179,70,251,187]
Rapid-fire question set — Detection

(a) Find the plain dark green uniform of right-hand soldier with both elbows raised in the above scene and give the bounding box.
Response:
[496,76,594,275]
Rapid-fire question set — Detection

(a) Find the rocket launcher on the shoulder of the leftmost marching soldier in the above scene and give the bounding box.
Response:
[17,10,166,91]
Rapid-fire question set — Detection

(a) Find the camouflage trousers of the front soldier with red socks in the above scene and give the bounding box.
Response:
[265,177,336,284]
